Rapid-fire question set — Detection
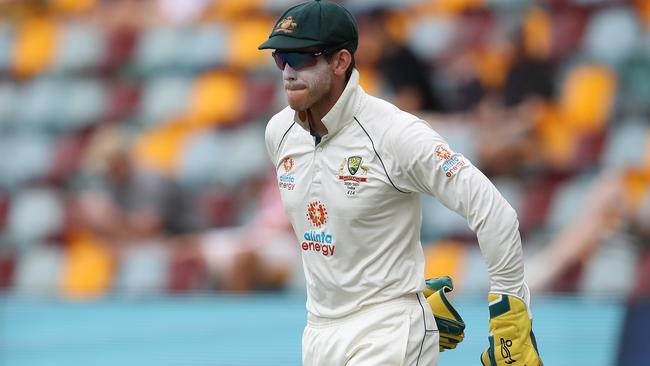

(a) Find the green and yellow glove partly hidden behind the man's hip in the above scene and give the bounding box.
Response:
[424,276,465,352]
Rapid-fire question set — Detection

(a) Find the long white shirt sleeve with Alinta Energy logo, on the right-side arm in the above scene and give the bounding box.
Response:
[391,121,527,298]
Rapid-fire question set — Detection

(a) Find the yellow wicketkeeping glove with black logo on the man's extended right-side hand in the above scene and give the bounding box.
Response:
[481,293,544,366]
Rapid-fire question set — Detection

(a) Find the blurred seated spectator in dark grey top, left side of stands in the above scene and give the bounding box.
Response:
[80,125,188,242]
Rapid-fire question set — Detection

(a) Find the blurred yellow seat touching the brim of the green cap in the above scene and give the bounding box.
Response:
[227,17,273,69]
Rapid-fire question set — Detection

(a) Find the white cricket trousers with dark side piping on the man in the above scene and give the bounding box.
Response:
[302,294,439,366]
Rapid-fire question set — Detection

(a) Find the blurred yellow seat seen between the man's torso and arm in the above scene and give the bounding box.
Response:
[424,240,467,285]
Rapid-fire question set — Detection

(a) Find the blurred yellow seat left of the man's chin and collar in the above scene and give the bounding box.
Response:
[187,71,246,127]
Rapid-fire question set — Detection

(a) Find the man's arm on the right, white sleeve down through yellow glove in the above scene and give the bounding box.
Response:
[393,121,542,366]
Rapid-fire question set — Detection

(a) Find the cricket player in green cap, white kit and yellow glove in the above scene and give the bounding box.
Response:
[259,0,541,366]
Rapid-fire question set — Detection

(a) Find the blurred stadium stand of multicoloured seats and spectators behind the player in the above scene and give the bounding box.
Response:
[0,0,650,299]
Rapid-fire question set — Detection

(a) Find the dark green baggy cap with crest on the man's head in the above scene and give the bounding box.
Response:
[258,0,359,53]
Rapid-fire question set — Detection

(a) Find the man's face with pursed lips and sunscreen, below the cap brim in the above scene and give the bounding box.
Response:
[282,50,333,111]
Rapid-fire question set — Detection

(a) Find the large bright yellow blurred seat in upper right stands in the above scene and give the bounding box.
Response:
[560,64,617,133]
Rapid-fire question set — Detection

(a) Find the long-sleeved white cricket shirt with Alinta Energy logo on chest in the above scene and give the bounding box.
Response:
[266,70,524,317]
